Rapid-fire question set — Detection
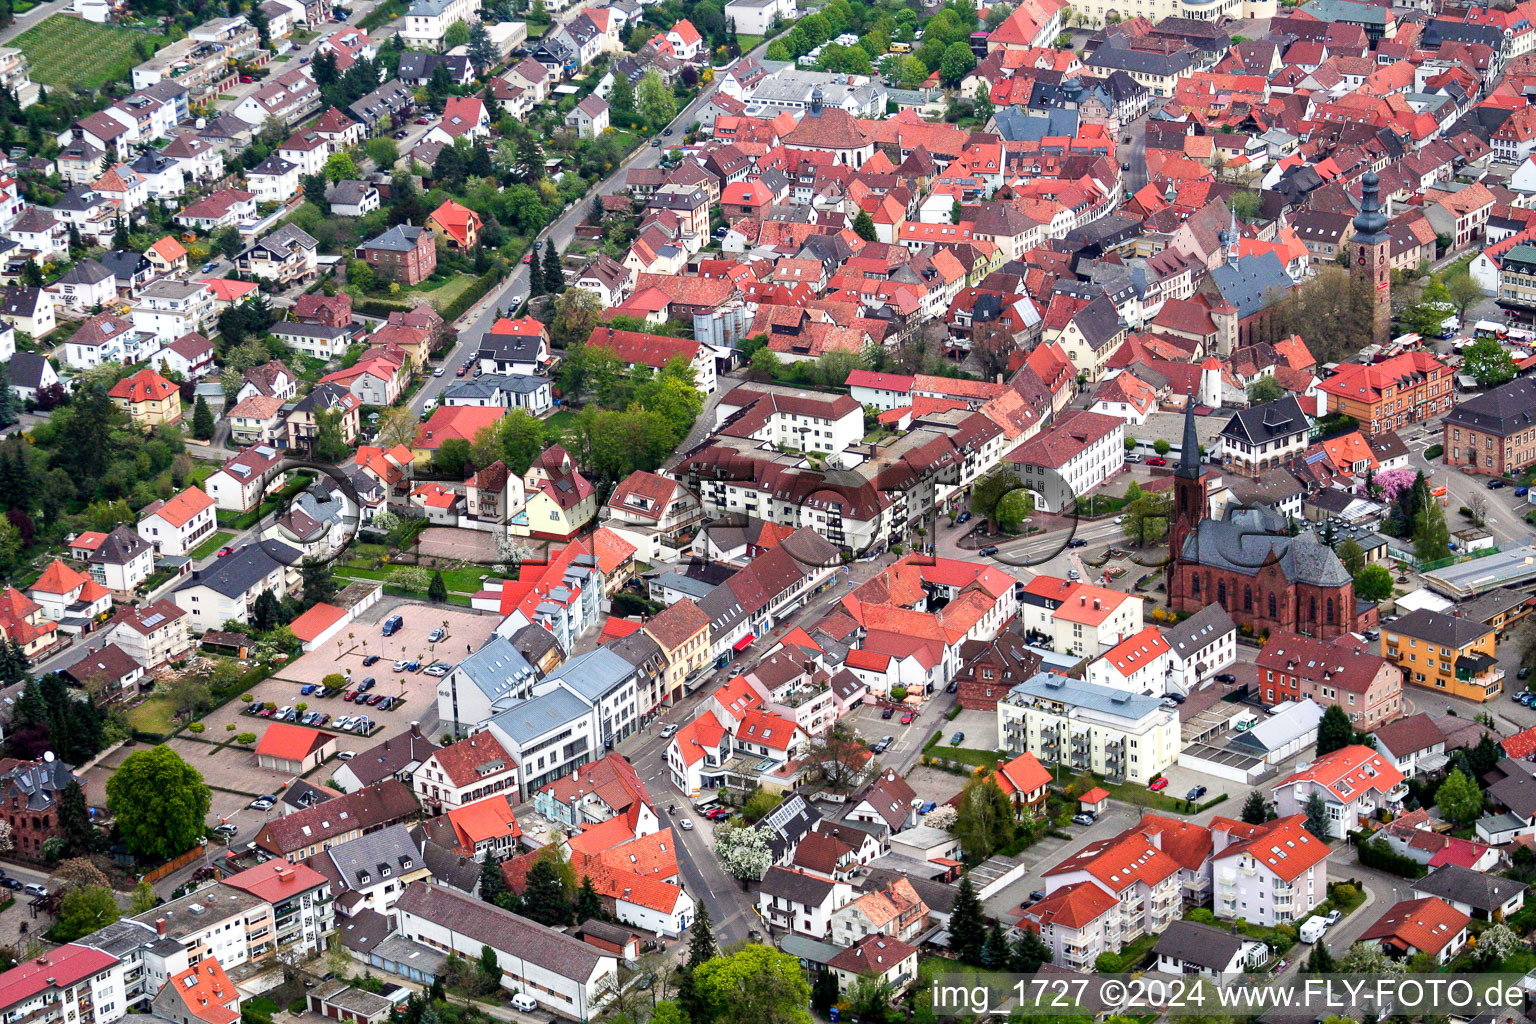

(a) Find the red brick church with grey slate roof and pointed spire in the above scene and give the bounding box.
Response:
[1167,410,1376,640]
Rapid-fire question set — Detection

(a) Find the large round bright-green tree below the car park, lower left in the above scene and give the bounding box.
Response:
[106,745,212,861]
